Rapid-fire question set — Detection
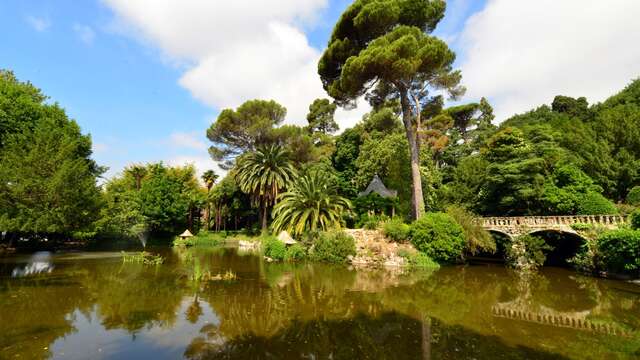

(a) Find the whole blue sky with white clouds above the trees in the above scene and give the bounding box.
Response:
[0,0,640,180]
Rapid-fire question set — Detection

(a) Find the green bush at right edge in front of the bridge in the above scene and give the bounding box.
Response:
[597,229,640,273]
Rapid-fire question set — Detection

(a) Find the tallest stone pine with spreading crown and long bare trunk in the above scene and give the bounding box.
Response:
[318,0,464,218]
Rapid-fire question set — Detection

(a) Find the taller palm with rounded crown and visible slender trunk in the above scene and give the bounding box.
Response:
[235,145,295,230]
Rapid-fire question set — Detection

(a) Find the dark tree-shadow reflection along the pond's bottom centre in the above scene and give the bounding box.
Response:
[184,312,562,360]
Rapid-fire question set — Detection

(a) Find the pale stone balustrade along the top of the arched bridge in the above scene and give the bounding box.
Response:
[479,215,627,239]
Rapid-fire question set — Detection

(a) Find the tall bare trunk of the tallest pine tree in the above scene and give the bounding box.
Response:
[400,89,424,219]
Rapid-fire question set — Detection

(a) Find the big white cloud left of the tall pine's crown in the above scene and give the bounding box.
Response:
[103,0,368,129]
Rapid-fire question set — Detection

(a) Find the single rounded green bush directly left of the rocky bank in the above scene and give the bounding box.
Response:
[310,231,356,263]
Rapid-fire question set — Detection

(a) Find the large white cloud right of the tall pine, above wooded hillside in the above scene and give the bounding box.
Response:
[459,0,640,121]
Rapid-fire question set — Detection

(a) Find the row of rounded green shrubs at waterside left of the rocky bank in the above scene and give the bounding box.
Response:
[261,231,356,264]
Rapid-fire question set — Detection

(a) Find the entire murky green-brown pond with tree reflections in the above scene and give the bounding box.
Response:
[0,248,640,359]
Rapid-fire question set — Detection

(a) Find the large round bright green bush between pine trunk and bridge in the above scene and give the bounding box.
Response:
[411,213,465,262]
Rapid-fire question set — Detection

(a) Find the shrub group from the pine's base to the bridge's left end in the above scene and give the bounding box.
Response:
[382,207,496,263]
